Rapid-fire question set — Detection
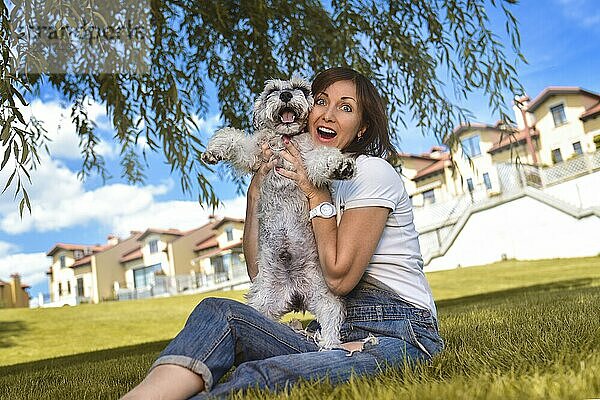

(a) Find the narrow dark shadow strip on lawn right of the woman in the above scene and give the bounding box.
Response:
[435,278,594,308]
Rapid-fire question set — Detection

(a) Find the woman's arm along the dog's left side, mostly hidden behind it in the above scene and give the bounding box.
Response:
[242,144,277,281]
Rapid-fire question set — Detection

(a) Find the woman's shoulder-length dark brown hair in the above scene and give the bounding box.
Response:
[312,67,396,158]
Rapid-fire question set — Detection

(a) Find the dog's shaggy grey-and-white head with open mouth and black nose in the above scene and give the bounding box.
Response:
[254,77,313,136]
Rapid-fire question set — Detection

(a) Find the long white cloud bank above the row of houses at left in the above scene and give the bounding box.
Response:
[0,149,245,236]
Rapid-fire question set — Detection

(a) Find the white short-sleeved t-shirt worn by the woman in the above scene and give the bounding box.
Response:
[331,155,436,316]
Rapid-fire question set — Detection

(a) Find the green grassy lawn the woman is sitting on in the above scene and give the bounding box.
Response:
[0,257,600,399]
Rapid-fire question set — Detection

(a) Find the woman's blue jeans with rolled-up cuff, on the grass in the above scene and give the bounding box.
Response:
[152,281,444,399]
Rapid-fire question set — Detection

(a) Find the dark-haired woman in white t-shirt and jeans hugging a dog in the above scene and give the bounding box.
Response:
[125,68,443,399]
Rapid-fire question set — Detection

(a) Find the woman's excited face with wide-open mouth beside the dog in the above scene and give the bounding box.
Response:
[308,81,366,150]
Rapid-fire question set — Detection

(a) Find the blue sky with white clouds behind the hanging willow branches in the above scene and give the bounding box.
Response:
[0,0,600,296]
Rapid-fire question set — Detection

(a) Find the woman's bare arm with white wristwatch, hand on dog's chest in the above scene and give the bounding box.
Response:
[277,144,390,295]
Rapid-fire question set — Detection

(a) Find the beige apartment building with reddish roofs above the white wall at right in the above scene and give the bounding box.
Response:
[398,87,600,207]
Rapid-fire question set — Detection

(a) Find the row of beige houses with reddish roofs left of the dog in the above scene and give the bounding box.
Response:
[47,218,245,305]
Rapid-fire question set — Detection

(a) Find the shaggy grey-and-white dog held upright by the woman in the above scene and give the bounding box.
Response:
[202,78,355,348]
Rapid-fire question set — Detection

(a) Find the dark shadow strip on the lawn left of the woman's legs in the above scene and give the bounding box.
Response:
[0,340,169,377]
